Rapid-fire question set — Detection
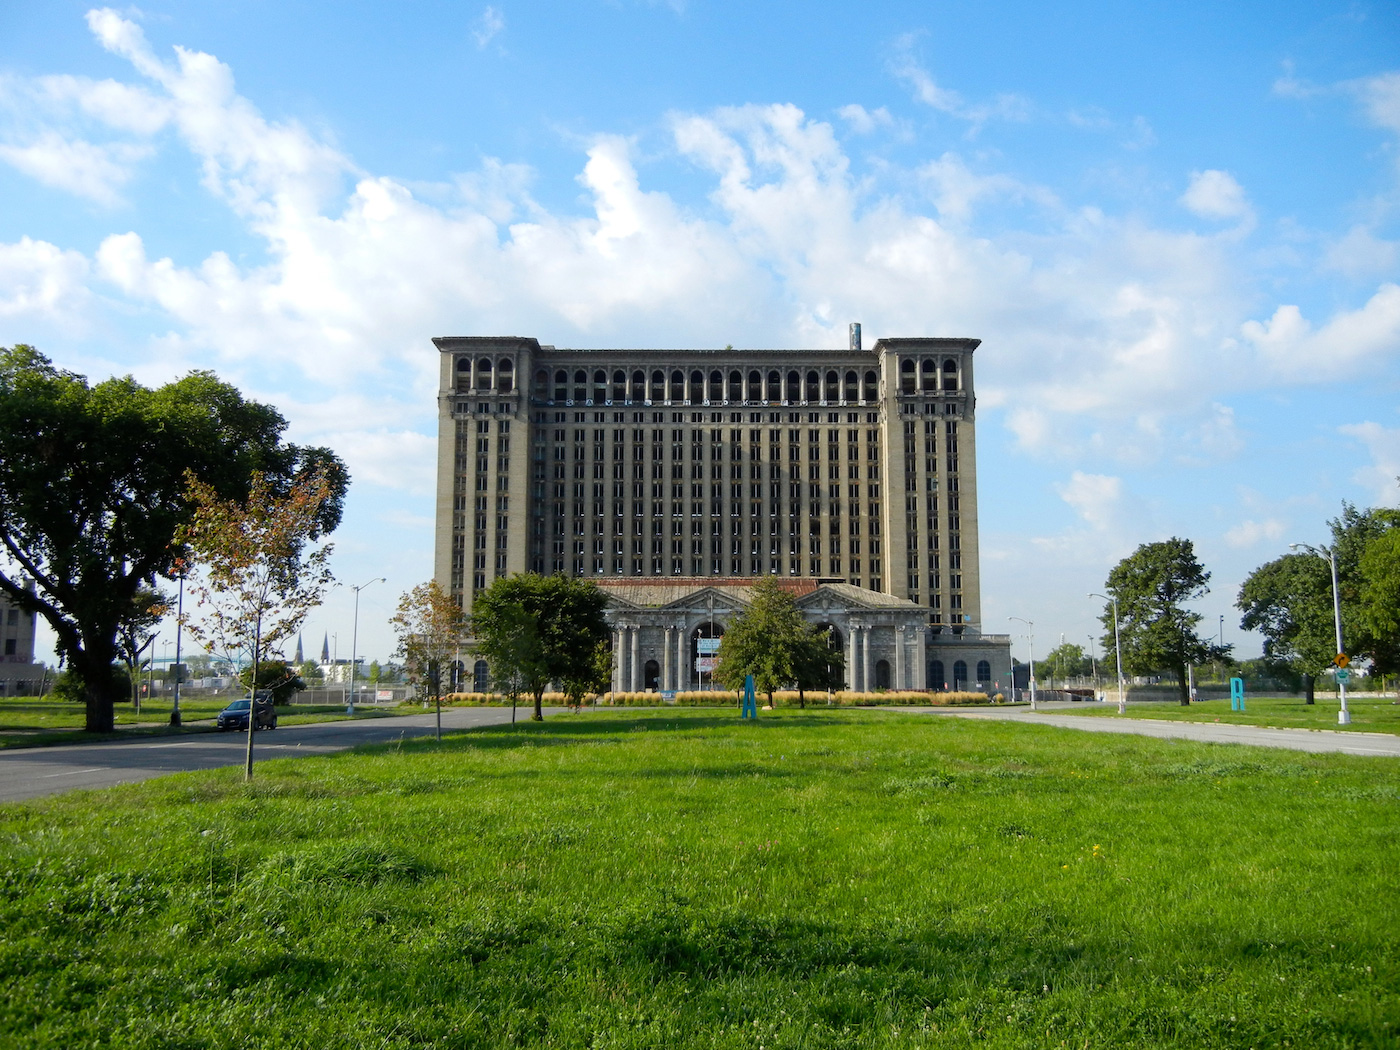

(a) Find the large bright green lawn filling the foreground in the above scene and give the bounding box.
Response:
[0,708,1400,1050]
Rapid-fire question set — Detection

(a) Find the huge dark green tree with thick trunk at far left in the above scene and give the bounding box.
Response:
[0,346,346,732]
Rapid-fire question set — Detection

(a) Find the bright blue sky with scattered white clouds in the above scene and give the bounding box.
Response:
[0,0,1400,658]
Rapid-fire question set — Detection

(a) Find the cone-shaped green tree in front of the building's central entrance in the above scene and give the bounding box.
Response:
[714,577,827,707]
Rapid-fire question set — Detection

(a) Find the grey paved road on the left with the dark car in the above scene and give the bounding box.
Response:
[0,707,553,802]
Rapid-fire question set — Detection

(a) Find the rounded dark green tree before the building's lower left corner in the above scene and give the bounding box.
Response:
[472,573,612,721]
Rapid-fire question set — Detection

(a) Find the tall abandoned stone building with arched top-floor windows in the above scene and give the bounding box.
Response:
[433,325,1011,690]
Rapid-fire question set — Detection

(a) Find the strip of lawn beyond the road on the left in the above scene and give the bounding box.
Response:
[0,696,403,749]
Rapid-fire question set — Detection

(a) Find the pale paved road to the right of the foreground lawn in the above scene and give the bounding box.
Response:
[896,703,1400,759]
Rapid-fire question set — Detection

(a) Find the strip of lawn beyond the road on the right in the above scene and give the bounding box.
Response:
[1054,693,1400,734]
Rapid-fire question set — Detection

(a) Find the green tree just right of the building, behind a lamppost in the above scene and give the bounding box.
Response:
[1100,538,1229,704]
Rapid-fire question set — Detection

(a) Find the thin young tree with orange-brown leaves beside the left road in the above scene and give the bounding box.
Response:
[181,468,336,780]
